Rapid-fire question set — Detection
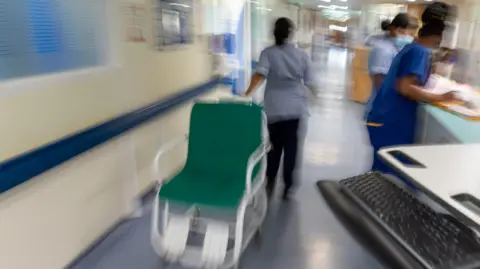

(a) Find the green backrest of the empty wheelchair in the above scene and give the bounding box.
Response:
[186,101,263,182]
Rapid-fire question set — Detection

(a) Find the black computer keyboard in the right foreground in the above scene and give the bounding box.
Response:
[340,173,480,269]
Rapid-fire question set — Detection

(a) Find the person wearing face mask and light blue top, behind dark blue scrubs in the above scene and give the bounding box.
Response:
[366,13,418,116]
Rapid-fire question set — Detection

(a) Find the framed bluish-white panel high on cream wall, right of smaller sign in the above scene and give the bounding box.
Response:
[154,0,194,49]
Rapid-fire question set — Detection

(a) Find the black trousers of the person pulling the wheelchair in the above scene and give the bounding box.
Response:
[267,119,300,191]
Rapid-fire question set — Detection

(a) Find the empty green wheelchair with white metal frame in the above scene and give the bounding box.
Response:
[151,101,270,269]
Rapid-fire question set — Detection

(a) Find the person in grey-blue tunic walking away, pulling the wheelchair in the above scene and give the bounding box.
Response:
[245,18,317,200]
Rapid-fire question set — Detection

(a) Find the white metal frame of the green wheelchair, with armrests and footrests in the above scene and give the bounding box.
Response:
[150,107,270,269]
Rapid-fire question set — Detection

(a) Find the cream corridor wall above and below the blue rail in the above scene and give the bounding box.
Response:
[0,0,216,269]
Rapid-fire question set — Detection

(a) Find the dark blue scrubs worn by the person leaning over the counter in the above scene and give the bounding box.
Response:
[367,43,431,184]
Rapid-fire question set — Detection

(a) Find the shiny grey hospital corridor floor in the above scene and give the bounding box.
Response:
[71,48,385,269]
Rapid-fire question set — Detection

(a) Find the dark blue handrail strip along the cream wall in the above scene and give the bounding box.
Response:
[0,78,222,193]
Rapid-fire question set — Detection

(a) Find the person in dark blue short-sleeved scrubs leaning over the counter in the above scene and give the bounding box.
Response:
[367,2,456,184]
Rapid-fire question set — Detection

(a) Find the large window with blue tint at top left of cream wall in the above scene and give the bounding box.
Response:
[0,0,106,80]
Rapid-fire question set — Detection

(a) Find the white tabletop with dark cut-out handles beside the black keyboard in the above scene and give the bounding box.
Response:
[378,144,480,227]
